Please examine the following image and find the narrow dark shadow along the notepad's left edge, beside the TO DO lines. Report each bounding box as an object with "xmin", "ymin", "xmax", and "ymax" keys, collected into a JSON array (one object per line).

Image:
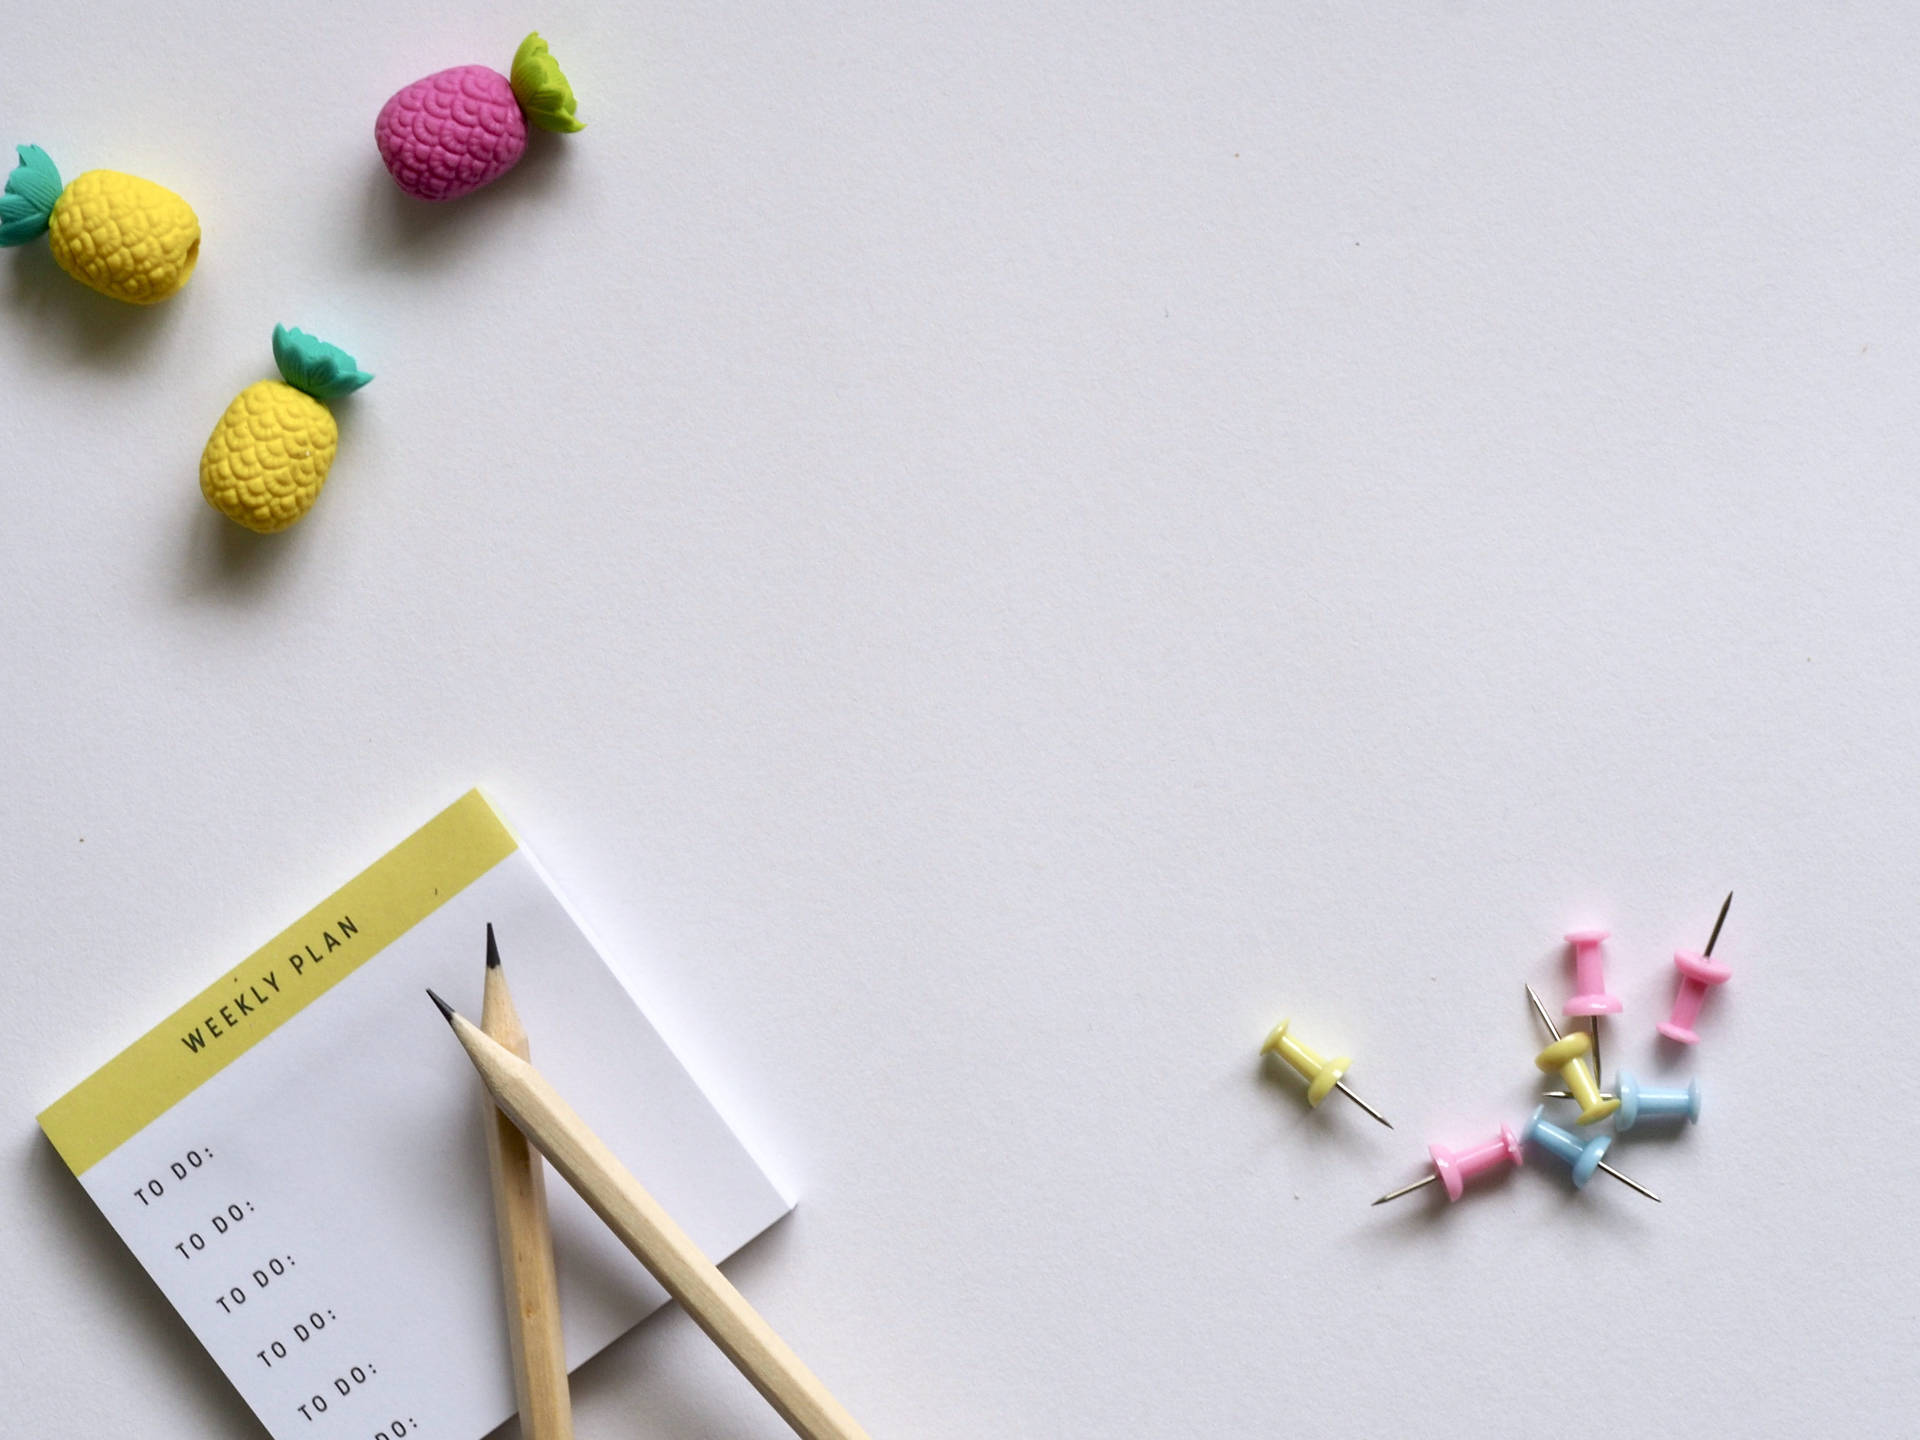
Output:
[{"xmin": 23, "ymin": 1129, "xmax": 261, "ymax": 1440}]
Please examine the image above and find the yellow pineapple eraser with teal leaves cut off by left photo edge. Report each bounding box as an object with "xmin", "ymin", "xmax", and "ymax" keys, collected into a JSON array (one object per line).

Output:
[{"xmin": 0, "ymin": 146, "xmax": 200, "ymax": 305}]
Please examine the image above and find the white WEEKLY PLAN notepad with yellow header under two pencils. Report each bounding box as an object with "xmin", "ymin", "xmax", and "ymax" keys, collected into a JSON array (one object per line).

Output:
[{"xmin": 40, "ymin": 791, "xmax": 789, "ymax": 1440}]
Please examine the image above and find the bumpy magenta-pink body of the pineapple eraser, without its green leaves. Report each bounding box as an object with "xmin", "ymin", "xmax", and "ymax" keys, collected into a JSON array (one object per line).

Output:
[{"xmin": 372, "ymin": 65, "xmax": 526, "ymax": 200}]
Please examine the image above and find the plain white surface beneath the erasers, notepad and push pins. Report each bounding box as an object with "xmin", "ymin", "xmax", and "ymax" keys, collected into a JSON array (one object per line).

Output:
[{"xmin": 0, "ymin": 0, "xmax": 1920, "ymax": 1440}]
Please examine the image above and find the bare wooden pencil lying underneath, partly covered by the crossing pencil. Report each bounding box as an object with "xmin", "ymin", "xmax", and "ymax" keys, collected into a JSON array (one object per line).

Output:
[{"xmin": 480, "ymin": 924, "xmax": 574, "ymax": 1440}]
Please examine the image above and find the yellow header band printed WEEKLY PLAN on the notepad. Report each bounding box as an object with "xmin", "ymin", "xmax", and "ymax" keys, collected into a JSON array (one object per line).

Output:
[{"xmin": 40, "ymin": 791, "xmax": 516, "ymax": 1175}]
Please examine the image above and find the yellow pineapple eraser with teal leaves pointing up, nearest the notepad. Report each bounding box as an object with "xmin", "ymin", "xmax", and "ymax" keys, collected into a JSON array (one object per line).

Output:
[{"xmin": 200, "ymin": 324, "xmax": 372, "ymax": 536}]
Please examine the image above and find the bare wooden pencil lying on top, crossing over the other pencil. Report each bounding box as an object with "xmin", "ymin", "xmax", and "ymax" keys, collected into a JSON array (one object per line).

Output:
[{"xmin": 428, "ymin": 991, "xmax": 868, "ymax": 1440}]
